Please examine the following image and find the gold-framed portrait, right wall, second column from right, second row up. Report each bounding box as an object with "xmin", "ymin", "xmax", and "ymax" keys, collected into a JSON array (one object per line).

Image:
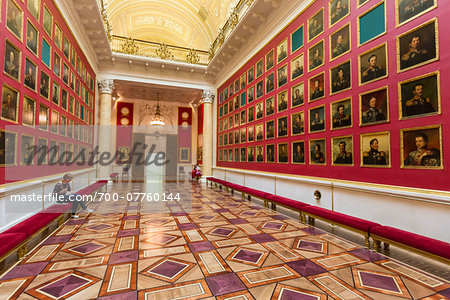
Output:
[{"xmin": 359, "ymin": 87, "xmax": 389, "ymax": 126}]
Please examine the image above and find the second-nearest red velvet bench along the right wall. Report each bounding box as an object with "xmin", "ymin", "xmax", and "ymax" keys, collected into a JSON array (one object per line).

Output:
[{"xmin": 301, "ymin": 205, "xmax": 380, "ymax": 248}]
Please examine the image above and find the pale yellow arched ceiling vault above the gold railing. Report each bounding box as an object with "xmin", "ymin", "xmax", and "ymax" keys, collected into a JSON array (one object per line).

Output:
[{"xmin": 107, "ymin": 0, "xmax": 238, "ymax": 51}]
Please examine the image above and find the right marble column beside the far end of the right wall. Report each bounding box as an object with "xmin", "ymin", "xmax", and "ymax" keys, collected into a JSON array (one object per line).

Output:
[{"xmin": 203, "ymin": 90, "xmax": 215, "ymax": 177}]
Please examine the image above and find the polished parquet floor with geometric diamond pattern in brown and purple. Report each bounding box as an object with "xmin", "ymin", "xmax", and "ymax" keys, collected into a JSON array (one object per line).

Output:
[{"xmin": 0, "ymin": 182, "xmax": 450, "ymax": 300}]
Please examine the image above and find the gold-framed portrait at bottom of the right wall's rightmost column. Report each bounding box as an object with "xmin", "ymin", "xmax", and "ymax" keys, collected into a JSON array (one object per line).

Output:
[{"xmin": 400, "ymin": 125, "xmax": 444, "ymax": 169}]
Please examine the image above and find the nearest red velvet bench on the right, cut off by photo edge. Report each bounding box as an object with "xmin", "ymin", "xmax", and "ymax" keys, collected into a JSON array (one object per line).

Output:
[{"xmin": 370, "ymin": 226, "xmax": 450, "ymax": 264}]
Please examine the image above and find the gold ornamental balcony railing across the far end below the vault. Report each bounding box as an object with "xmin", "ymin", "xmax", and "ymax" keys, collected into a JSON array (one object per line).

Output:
[{"xmin": 111, "ymin": 35, "xmax": 209, "ymax": 65}]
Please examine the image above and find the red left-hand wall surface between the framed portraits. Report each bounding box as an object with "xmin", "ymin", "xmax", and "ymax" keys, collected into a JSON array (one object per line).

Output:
[{"xmin": 0, "ymin": 0, "xmax": 96, "ymax": 184}]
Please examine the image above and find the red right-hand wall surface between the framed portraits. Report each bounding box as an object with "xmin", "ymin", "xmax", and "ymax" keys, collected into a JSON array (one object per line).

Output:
[{"xmin": 217, "ymin": 0, "xmax": 450, "ymax": 191}]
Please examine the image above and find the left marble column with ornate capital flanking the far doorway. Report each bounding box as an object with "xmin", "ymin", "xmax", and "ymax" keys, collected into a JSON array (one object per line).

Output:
[{"xmin": 97, "ymin": 79, "xmax": 115, "ymax": 179}]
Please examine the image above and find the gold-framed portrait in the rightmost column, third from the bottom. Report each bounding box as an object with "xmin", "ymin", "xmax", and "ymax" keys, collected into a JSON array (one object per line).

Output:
[{"xmin": 397, "ymin": 18, "xmax": 439, "ymax": 72}]
